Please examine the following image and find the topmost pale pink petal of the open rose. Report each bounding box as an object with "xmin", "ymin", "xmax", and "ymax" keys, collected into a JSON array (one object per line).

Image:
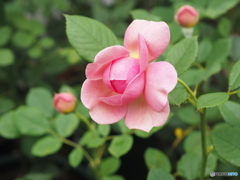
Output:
[{"xmin": 124, "ymin": 20, "xmax": 170, "ymax": 61}]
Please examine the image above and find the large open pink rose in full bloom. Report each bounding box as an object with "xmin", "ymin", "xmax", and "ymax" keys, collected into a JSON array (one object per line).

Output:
[{"xmin": 81, "ymin": 20, "xmax": 177, "ymax": 132}]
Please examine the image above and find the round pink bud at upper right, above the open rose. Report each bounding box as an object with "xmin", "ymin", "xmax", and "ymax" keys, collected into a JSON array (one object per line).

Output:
[{"xmin": 174, "ymin": 5, "xmax": 199, "ymax": 27}]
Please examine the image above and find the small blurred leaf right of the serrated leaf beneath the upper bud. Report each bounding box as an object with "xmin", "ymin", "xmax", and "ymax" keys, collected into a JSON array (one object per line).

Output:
[{"xmin": 197, "ymin": 39, "xmax": 212, "ymax": 63}]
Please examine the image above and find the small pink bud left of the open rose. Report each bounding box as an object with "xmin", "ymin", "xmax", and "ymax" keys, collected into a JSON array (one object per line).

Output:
[{"xmin": 53, "ymin": 92, "xmax": 76, "ymax": 113}]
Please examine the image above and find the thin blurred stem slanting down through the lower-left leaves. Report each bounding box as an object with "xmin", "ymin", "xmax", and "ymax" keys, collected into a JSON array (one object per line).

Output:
[{"xmin": 48, "ymin": 129, "xmax": 95, "ymax": 169}]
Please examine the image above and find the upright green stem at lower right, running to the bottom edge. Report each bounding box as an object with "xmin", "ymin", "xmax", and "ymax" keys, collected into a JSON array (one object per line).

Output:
[{"xmin": 200, "ymin": 109, "xmax": 207, "ymax": 180}]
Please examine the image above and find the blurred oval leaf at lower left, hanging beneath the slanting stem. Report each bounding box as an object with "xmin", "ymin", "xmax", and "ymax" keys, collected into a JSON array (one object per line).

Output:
[{"xmin": 32, "ymin": 136, "xmax": 62, "ymax": 157}]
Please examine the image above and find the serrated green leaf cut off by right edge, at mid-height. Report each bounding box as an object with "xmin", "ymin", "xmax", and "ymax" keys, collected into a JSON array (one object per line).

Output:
[{"xmin": 229, "ymin": 60, "xmax": 240, "ymax": 91}]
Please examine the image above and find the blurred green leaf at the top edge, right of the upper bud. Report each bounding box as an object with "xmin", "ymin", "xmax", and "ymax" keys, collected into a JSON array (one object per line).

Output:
[{"xmin": 205, "ymin": 0, "xmax": 239, "ymax": 19}]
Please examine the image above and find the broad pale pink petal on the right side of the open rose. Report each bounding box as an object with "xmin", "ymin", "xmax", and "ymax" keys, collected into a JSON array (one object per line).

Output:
[{"xmin": 144, "ymin": 61, "xmax": 177, "ymax": 111}]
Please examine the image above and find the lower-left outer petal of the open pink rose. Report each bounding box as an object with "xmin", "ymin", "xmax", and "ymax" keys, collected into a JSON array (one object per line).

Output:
[{"xmin": 89, "ymin": 101, "xmax": 127, "ymax": 124}]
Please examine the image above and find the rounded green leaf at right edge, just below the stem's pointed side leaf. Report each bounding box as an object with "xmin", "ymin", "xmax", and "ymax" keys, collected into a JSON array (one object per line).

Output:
[{"xmin": 219, "ymin": 101, "xmax": 240, "ymax": 127}]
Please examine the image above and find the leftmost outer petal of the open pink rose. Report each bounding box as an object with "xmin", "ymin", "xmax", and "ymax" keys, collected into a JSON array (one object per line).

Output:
[{"xmin": 81, "ymin": 79, "xmax": 113, "ymax": 109}]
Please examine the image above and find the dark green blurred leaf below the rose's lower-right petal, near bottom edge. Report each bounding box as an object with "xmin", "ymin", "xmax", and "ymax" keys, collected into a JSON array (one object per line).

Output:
[{"xmin": 144, "ymin": 148, "xmax": 171, "ymax": 173}]
